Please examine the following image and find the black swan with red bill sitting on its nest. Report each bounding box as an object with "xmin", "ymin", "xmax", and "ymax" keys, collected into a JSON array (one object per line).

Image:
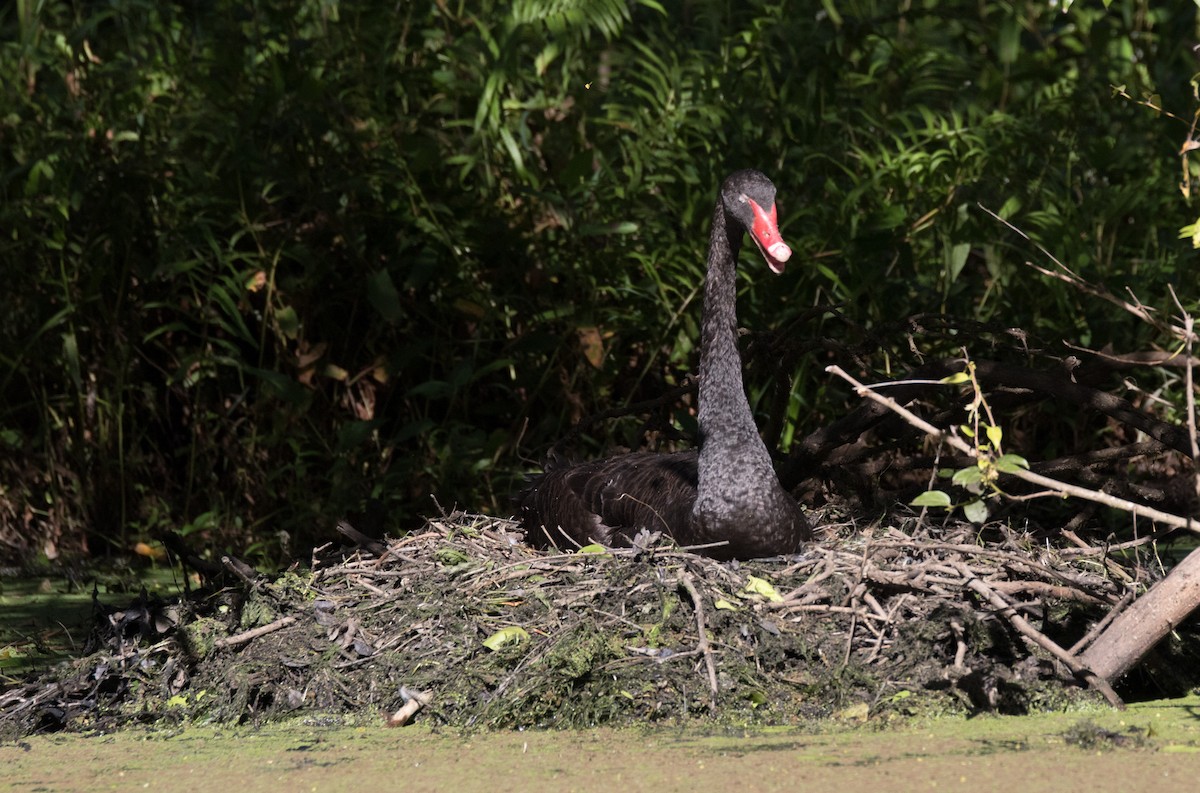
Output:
[{"xmin": 516, "ymin": 170, "xmax": 810, "ymax": 559}]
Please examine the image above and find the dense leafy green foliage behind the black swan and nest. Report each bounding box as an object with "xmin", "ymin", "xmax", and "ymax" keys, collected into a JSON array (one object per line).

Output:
[{"xmin": 0, "ymin": 0, "xmax": 1198, "ymax": 558}]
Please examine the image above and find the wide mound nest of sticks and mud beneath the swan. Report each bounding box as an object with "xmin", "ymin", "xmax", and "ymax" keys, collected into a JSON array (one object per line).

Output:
[{"xmin": 7, "ymin": 503, "xmax": 1190, "ymax": 735}]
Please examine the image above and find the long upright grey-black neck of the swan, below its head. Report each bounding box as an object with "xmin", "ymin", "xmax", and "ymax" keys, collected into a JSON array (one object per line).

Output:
[{"xmin": 696, "ymin": 200, "xmax": 778, "ymax": 515}]
